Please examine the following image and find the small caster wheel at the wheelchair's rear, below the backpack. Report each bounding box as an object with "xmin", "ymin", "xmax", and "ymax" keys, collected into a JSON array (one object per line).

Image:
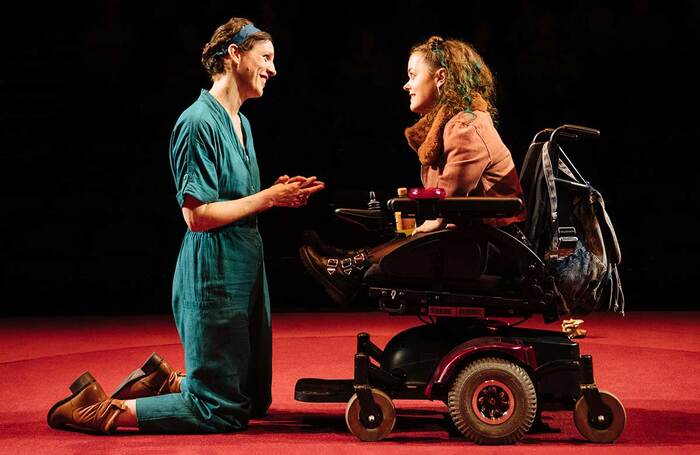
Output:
[{"xmin": 574, "ymin": 390, "xmax": 627, "ymax": 443}]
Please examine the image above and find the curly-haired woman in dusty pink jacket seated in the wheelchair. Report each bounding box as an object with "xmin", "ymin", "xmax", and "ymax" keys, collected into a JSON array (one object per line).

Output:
[{"xmin": 300, "ymin": 36, "xmax": 526, "ymax": 304}]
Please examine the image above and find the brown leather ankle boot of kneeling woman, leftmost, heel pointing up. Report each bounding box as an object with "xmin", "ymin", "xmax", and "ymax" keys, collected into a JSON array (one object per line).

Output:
[{"xmin": 46, "ymin": 372, "xmax": 127, "ymax": 433}]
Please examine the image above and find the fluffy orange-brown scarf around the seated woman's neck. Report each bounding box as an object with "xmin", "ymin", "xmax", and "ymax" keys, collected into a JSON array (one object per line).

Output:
[{"xmin": 405, "ymin": 93, "xmax": 488, "ymax": 168}]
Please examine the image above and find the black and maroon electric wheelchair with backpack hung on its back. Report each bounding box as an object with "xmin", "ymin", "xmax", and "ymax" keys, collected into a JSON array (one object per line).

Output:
[{"xmin": 295, "ymin": 125, "xmax": 626, "ymax": 444}]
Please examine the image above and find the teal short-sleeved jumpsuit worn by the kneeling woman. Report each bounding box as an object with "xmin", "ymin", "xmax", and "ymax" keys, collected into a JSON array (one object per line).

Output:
[{"xmin": 136, "ymin": 90, "xmax": 272, "ymax": 433}]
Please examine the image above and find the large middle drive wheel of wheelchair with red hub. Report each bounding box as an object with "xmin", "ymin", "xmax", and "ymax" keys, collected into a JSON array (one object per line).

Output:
[{"xmin": 447, "ymin": 358, "xmax": 537, "ymax": 444}]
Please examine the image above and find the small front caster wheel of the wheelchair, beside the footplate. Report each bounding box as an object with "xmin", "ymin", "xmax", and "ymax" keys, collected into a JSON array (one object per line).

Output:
[{"xmin": 345, "ymin": 389, "xmax": 396, "ymax": 441}]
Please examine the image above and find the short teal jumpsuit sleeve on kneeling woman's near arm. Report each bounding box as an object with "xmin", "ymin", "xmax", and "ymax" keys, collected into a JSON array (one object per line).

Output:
[{"xmin": 170, "ymin": 122, "xmax": 219, "ymax": 207}]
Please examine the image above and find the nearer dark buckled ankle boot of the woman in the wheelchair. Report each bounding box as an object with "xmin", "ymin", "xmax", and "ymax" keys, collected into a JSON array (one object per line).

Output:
[{"xmin": 299, "ymin": 245, "xmax": 370, "ymax": 305}]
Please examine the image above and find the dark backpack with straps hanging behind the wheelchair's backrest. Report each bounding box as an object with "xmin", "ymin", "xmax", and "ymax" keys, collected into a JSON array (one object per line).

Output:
[{"xmin": 520, "ymin": 125, "xmax": 625, "ymax": 316}]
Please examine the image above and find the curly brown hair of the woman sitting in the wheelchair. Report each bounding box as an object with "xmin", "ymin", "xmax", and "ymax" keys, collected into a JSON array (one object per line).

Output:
[{"xmin": 409, "ymin": 36, "xmax": 498, "ymax": 122}]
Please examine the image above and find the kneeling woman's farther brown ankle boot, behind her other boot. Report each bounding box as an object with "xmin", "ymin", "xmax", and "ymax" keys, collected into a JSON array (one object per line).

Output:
[{"xmin": 112, "ymin": 352, "xmax": 185, "ymax": 400}]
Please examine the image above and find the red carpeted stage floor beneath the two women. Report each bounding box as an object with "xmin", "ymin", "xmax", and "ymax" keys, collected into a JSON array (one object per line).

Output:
[{"xmin": 0, "ymin": 312, "xmax": 700, "ymax": 455}]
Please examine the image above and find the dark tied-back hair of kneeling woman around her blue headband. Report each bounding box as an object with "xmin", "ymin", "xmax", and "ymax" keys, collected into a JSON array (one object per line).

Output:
[{"xmin": 202, "ymin": 17, "xmax": 272, "ymax": 78}]
